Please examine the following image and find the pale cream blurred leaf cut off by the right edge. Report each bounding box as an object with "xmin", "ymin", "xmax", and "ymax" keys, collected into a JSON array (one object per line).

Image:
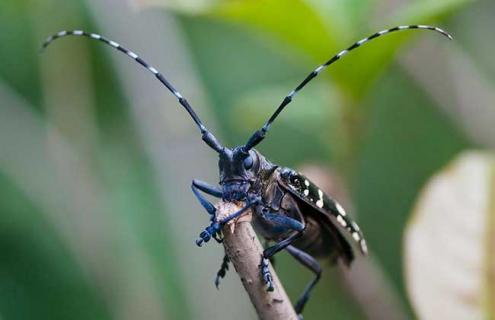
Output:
[{"xmin": 404, "ymin": 152, "xmax": 495, "ymax": 319}]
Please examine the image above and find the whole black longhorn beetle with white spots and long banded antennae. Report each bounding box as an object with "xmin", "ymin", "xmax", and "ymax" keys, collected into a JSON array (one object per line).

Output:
[{"xmin": 42, "ymin": 25, "xmax": 452, "ymax": 315}]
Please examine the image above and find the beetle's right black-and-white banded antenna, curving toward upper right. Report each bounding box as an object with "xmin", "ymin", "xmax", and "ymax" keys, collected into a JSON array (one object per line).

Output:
[{"xmin": 244, "ymin": 25, "xmax": 452, "ymax": 150}]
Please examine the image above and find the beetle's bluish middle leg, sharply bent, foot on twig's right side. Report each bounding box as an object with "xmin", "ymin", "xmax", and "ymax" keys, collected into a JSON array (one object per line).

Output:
[{"xmin": 260, "ymin": 213, "xmax": 305, "ymax": 291}]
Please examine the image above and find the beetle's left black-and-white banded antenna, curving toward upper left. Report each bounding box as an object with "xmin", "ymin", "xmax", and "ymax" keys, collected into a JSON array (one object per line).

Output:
[{"xmin": 41, "ymin": 30, "xmax": 223, "ymax": 153}]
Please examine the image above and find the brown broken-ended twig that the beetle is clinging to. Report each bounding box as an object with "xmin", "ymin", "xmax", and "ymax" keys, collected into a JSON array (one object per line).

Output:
[{"xmin": 217, "ymin": 202, "xmax": 297, "ymax": 320}]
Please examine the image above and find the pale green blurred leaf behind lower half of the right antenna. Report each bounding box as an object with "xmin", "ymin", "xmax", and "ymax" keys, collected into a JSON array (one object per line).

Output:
[{"xmin": 228, "ymin": 80, "xmax": 342, "ymax": 165}]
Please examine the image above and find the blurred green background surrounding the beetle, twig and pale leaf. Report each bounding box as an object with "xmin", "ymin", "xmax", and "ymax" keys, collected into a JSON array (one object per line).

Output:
[{"xmin": 0, "ymin": 0, "xmax": 495, "ymax": 319}]
